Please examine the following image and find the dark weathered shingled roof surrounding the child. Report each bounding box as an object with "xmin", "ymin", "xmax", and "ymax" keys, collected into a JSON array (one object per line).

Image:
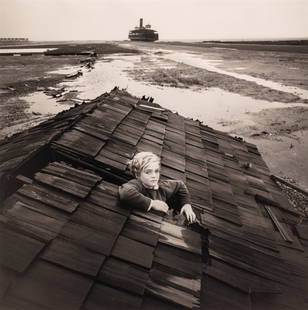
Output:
[{"xmin": 0, "ymin": 90, "xmax": 308, "ymax": 310}]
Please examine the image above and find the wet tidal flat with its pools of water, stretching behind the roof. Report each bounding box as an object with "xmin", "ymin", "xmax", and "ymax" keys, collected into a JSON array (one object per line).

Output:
[{"xmin": 0, "ymin": 42, "xmax": 308, "ymax": 189}]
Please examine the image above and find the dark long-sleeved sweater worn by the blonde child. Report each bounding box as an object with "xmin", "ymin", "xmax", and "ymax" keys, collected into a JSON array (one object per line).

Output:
[{"xmin": 119, "ymin": 179, "xmax": 191, "ymax": 211}]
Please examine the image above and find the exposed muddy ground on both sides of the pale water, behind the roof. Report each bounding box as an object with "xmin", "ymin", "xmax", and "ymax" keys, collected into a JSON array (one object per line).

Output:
[{"xmin": 0, "ymin": 42, "xmax": 308, "ymax": 190}]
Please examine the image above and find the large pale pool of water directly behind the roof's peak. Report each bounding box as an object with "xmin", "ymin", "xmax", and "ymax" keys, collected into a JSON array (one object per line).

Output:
[{"xmin": 54, "ymin": 55, "xmax": 305, "ymax": 131}]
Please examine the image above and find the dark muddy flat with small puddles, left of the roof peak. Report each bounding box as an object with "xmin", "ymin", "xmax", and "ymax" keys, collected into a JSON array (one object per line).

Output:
[{"xmin": 0, "ymin": 42, "xmax": 136, "ymax": 140}]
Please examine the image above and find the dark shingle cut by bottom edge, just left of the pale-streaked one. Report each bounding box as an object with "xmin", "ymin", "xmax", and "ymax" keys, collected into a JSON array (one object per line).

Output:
[{"xmin": 84, "ymin": 283, "xmax": 142, "ymax": 310}]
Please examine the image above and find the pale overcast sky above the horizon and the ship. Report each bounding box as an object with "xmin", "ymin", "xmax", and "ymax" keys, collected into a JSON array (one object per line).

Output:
[{"xmin": 0, "ymin": 0, "xmax": 308, "ymax": 40}]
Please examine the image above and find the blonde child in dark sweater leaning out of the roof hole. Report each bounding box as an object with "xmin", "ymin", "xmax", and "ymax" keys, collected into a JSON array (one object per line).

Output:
[{"xmin": 119, "ymin": 152, "xmax": 196, "ymax": 223}]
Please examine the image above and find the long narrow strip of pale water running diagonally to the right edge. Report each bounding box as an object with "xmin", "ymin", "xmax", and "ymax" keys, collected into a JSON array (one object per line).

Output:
[{"xmin": 162, "ymin": 52, "xmax": 308, "ymax": 99}]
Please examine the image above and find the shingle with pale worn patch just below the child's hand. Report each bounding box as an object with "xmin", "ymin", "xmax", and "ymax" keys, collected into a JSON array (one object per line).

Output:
[{"xmin": 159, "ymin": 222, "xmax": 202, "ymax": 255}]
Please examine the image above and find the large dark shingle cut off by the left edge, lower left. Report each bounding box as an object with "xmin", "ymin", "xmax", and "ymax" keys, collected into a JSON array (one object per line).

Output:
[{"xmin": 0, "ymin": 227, "xmax": 45, "ymax": 272}]
